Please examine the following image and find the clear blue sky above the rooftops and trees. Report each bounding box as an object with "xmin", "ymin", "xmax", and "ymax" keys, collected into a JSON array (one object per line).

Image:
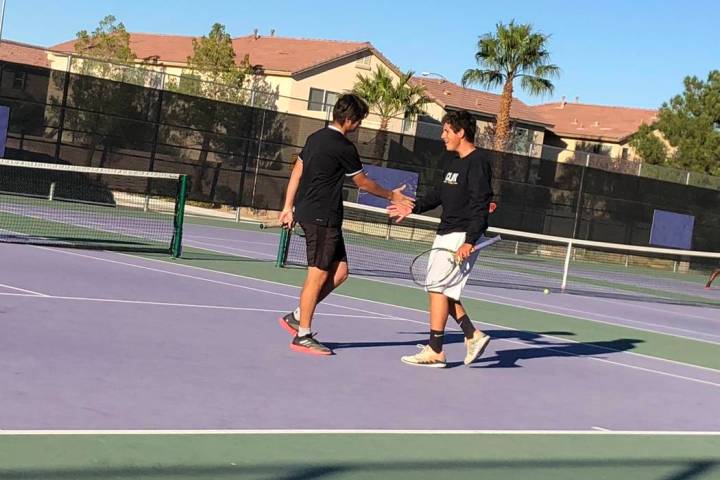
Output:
[{"xmin": 3, "ymin": 0, "xmax": 720, "ymax": 108}]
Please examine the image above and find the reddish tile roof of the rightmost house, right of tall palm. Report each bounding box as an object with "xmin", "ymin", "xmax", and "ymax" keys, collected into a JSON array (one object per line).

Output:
[{"xmin": 531, "ymin": 102, "xmax": 657, "ymax": 142}]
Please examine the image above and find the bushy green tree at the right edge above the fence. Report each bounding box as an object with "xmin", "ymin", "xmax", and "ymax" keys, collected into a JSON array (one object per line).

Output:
[{"xmin": 654, "ymin": 70, "xmax": 720, "ymax": 175}]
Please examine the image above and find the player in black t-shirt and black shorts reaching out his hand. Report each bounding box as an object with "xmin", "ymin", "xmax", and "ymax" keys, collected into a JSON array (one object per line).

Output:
[{"xmin": 280, "ymin": 94, "xmax": 413, "ymax": 355}]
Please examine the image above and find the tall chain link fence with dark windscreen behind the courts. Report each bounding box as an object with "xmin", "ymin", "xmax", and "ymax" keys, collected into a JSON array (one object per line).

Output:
[{"xmin": 0, "ymin": 57, "xmax": 720, "ymax": 250}]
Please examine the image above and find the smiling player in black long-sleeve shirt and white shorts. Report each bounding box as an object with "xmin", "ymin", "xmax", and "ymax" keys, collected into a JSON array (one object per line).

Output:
[{"xmin": 388, "ymin": 111, "xmax": 492, "ymax": 368}]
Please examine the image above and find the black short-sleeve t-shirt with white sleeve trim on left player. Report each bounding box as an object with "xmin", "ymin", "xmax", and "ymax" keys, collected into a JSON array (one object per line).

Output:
[{"xmin": 295, "ymin": 127, "xmax": 363, "ymax": 227}]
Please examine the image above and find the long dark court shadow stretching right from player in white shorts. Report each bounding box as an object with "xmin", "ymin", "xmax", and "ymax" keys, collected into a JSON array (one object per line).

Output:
[{"xmin": 472, "ymin": 338, "xmax": 644, "ymax": 368}]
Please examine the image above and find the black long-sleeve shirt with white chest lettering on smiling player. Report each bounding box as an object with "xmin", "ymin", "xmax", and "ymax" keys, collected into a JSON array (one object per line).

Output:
[{"xmin": 413, "ymin": 150, "xmax": 492, "ymax": 244}]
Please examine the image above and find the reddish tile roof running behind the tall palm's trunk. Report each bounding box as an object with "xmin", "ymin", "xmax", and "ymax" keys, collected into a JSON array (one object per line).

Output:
[{"xmin": 413, "ymin": 77, "xmax": 552, "ymax": 126}]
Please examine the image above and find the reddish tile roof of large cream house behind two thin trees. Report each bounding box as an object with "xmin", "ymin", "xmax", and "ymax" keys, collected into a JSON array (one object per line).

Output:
[{"xmin": 52, "ymin": 33, "xmax": 374, "ymax": 74}]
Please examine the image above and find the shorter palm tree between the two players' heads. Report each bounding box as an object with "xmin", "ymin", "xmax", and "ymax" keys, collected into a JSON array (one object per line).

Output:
[{"xmin": 352, "ymin": 66, "xmax": 431, "ymax": 158}]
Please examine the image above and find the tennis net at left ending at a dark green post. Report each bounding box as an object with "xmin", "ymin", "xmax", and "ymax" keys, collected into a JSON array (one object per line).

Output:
[{"xmin": 0, "ymin": 159, "xmax": 187, "ymax": 256}]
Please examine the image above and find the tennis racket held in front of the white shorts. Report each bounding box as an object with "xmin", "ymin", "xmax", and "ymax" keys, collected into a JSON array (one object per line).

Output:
[{"xmin": 410, "ymin": 235, "xmax": 500, "ymax": 288}]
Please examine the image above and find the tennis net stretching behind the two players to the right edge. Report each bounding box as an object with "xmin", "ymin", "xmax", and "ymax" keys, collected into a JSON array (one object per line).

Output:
[{"xmin": 277, "ymin": 202, "xmax": 720, "ymax": 305}]
